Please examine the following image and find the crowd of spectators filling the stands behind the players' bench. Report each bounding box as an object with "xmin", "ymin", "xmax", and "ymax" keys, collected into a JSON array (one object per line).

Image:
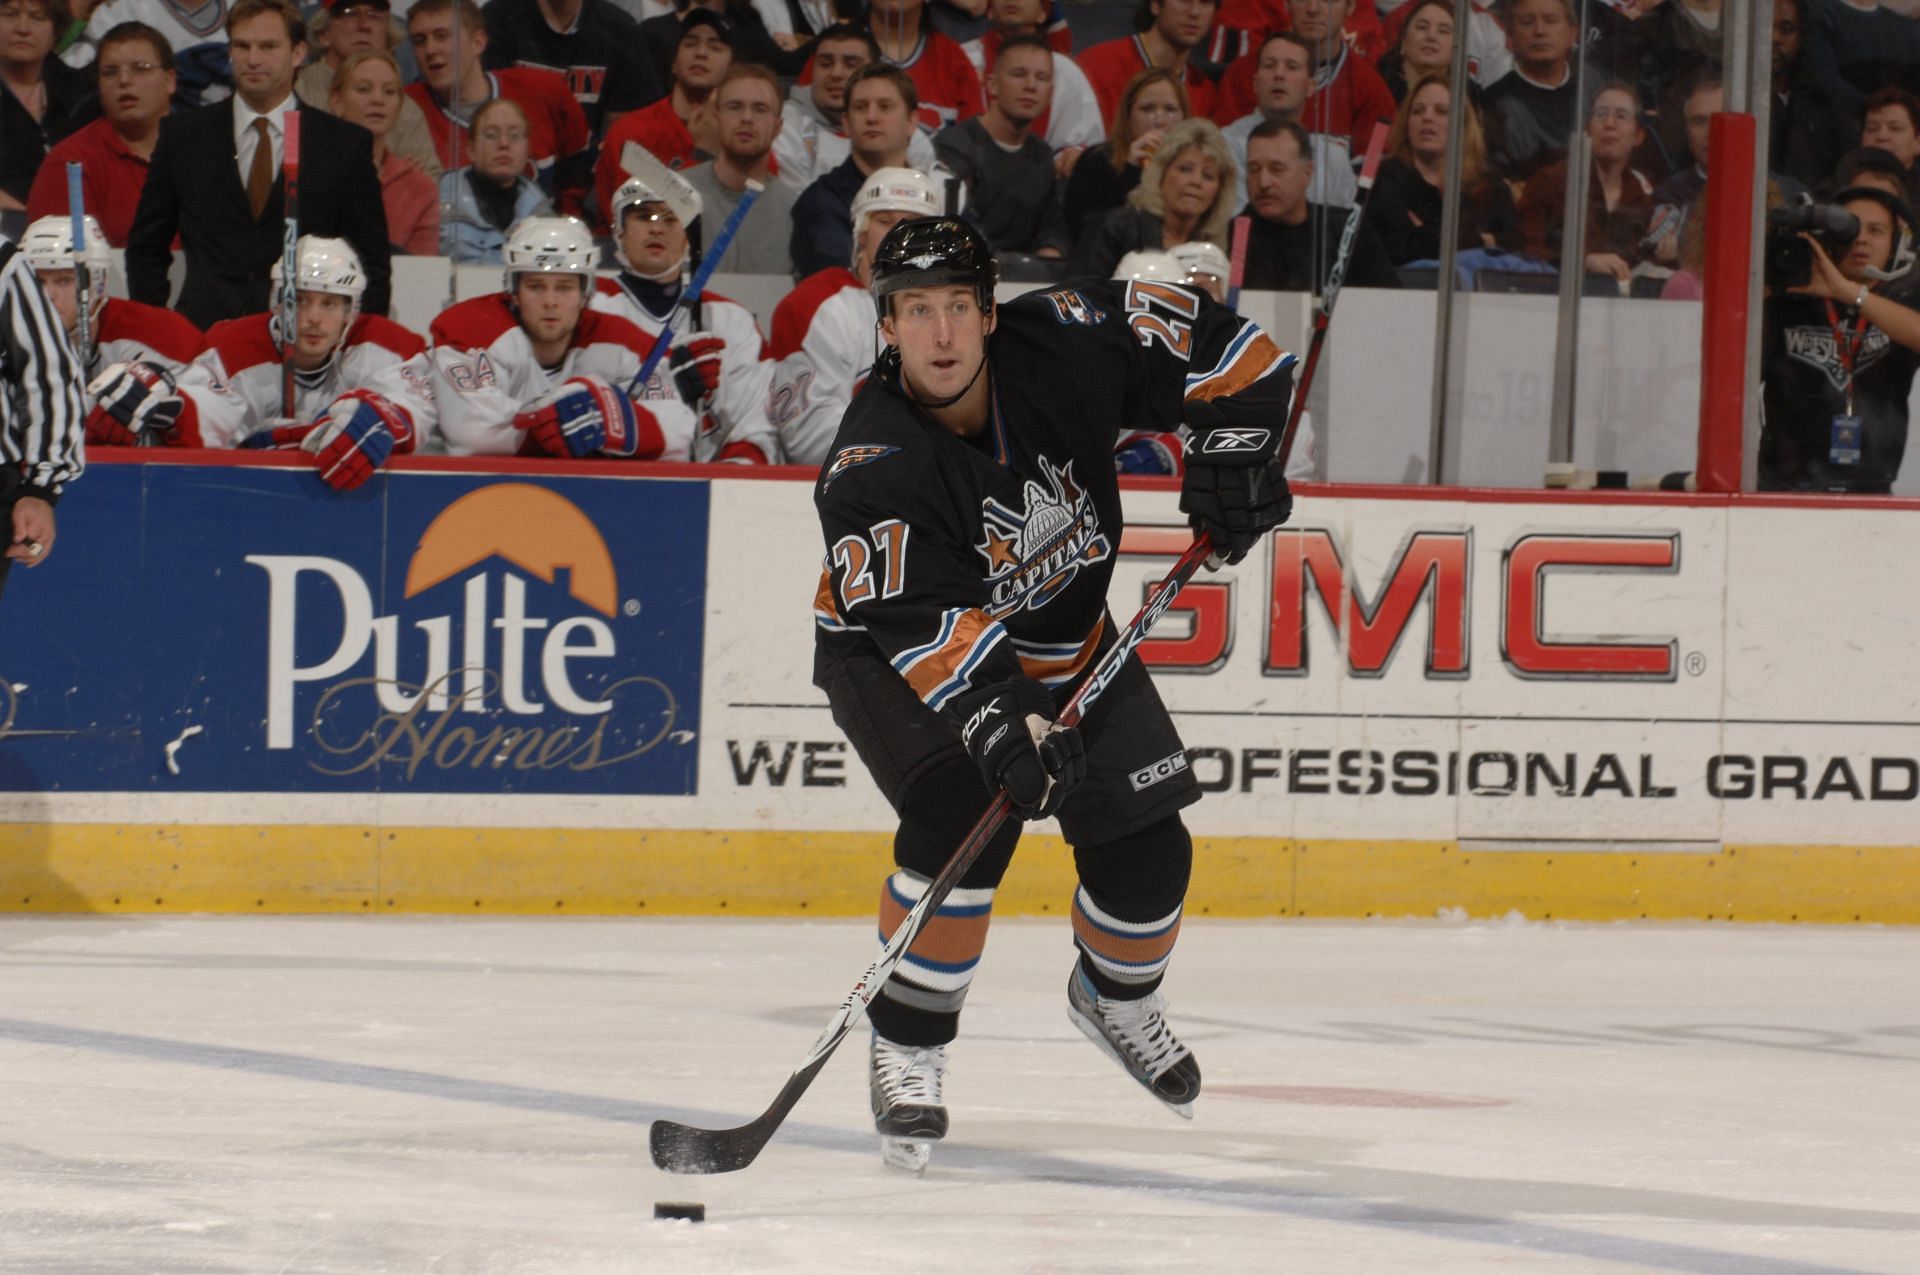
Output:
[{"xmin": 0, "ymin": 0, "xmax": 1920, "ymax": 487}]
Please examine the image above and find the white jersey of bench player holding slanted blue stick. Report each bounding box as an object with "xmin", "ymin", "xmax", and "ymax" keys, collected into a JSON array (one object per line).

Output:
[{"xmin": 593, "ymin": 278, "xmax": 780, "ymax": 463}]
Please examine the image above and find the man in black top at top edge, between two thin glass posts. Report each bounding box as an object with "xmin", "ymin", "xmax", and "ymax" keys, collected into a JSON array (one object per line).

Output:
[{"xmin": 1482, "ymin": 0, "xmax": 1597, "ymax": 182}]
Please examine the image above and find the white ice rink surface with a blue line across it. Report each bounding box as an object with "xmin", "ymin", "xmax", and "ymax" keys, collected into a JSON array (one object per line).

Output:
[{"xmin": 0, "ymin": 918, "xmax": 1920, "ymax": 1275}]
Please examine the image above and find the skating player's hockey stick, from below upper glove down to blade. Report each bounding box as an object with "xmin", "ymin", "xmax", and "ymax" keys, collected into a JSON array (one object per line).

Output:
[{"xmin": 647, "ymin": 534, "xmax": 1213, "ymax": 1173}]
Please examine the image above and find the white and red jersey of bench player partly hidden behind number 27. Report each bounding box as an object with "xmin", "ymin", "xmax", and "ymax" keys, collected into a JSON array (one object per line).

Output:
[{"xmin": 768, "ymin": 265, "xmax": 877, "ymax": 465}]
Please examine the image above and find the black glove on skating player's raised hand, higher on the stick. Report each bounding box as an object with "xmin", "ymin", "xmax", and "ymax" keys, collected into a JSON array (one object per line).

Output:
[{"xmin": 1181, "ymin": 403, "xmax": 1294, "ymax": 566}]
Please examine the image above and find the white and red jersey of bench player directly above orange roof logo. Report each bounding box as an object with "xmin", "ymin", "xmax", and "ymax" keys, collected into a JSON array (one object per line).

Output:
[{"xmin": 428, "ymin": 292, "xmax": 697, "ymax": 461}]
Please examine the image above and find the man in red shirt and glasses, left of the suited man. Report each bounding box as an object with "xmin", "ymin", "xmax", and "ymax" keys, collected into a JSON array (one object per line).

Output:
[{"xmin": 27, "ymin": 23, "xmax": 175, "ymax": 248}]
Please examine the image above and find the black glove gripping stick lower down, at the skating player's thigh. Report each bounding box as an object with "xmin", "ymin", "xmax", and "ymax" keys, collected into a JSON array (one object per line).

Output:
[{"xmin": 954, "ymin": 678, "xmax": 1087, "ymax": 820}]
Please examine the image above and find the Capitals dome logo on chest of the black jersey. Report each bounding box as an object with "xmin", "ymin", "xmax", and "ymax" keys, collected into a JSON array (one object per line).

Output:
[{"xmin": 973, "ymin": 457, "xmax": 1114, "ymax": 620}]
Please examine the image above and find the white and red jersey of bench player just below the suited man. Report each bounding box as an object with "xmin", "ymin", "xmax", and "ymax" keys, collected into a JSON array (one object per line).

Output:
[{"xmin": 177, "ymin": 315, "xmax": 434, "ymax": 449}]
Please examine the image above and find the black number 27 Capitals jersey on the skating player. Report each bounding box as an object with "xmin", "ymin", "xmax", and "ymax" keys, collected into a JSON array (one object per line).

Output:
[{"xmin": 814, "ymin": 280, "xmax": 1294, "ymax": 709}]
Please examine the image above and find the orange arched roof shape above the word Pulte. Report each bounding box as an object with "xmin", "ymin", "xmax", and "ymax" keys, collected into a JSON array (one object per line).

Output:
[{"xmin": 407, "ymin": 482, "xmax": 620, "ymax": 618}]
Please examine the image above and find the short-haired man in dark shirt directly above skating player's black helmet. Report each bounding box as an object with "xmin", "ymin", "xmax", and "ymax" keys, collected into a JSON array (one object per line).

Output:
[{"xmin": 933, "ymin": 35, "xmax": 1071, "ymax": 257}]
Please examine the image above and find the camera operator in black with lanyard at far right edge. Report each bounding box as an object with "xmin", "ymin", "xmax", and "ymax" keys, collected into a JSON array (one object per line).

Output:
[{"xmin": 1761, "ymin": 186, "xmax": 1920, "ymax": 493}]
